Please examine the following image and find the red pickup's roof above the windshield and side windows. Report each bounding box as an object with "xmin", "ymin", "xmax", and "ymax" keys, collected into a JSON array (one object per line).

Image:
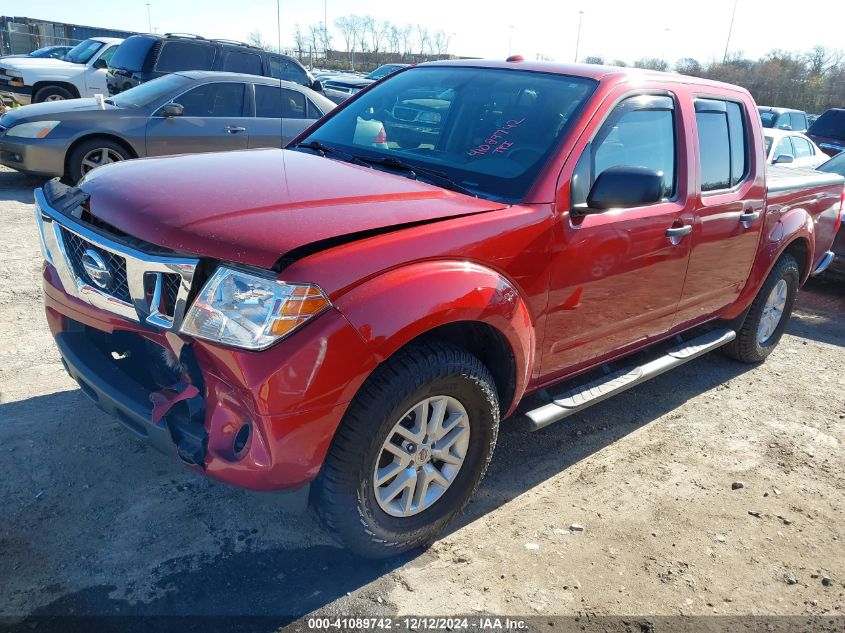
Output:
[{"xmin": 418, "ymin": 59, "xmax": 747, "ymax": 92}]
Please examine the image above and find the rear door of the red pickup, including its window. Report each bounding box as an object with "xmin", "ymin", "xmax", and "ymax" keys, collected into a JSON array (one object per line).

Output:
[{"xmin": 678, "ymin": 97, "xmax": 766, "ymax": 323}]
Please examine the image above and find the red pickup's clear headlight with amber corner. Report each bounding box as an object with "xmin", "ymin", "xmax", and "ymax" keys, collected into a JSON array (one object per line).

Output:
[{"xmin": 181, "ymin": 267, "xmax": 331, "ymax": 350}]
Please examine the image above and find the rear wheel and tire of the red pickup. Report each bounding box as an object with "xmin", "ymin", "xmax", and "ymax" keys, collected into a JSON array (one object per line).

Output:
[{"xmin": 724, "ymin": 254, "xmax": 801, "ymax": 363}]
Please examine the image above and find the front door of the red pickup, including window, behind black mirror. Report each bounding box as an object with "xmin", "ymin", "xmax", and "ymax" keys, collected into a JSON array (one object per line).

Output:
[{"xmin": 542, "ymin": 94, "xmax": 694, "ymax": 380}]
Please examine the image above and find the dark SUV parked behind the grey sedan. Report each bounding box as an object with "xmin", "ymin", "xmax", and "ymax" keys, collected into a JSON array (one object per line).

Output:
[{"xmin": 108, "ymin": 33, "xmax": 322, "ymax": 95}]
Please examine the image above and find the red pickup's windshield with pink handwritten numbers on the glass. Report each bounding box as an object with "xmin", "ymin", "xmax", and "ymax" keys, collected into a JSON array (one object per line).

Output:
[{"xmin": 296, "ymin": 66, "xmax": 596, "ymax": 202}]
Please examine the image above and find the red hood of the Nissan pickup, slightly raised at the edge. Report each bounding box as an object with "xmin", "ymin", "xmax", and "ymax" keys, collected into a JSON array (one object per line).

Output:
[{"xmin": 80, "ymin": 149, "xmax": 504, "ymax": 268}]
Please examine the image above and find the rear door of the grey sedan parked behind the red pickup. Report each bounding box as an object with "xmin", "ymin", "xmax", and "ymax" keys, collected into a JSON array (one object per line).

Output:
[{"xmin": 249, "ymin": 84, "xmax": 317, "ymax": 147}]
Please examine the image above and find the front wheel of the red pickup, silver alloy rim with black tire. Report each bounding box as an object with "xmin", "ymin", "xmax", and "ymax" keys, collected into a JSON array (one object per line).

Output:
[{"xmin": 315, "ymin": 341, "xmax": 499, "ymax": 558}]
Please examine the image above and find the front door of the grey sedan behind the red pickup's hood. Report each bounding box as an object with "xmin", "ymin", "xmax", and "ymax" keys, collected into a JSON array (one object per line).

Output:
[{"xmin": 147, "ymin": 82, "xmax": 253, "ymax": 156}]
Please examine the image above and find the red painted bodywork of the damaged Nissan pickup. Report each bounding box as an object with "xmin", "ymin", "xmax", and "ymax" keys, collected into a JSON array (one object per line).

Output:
[{"xmin": 44, "ymin": 61, "xmax": 841, "ymax": 490}]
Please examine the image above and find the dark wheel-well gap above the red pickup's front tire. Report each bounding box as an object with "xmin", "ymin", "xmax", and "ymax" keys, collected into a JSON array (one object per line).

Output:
[{"xmin": 411, "ymin": 321, "xmax": 516, "ymax": 415}]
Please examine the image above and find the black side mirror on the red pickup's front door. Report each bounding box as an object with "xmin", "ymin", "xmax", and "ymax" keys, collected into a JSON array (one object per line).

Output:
[{"xmin": 577, "ymin": 165, "xmax": 663, "ymax": 213}]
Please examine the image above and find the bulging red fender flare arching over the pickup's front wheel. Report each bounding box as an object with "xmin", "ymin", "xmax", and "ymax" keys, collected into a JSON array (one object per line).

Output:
[{"xmin": 335, "ymin": 261, "xmax": 535, "ymax": 414}]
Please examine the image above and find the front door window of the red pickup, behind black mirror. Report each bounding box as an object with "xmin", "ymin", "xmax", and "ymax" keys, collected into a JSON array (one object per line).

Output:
[{"xmin": 572, "ymin": 95, "xmax": 677, "ymax": 205}]
